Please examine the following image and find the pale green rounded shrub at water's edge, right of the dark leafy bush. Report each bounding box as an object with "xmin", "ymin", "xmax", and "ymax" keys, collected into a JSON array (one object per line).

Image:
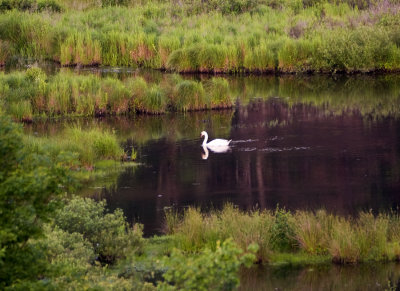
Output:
[{"xmin": 55, "ymin": 197, "xmax": 143, "ymax": 264}]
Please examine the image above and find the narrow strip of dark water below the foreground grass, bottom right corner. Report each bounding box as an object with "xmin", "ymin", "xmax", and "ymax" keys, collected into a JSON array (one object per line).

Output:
[{"xmin": 239, "ymin": 263, "xmax": 400, "ymax": 291}]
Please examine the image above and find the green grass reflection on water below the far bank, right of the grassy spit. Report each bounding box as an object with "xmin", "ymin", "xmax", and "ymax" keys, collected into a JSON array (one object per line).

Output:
[{"xmin": 232, "ymin": 75, "xmax": 400, "ymax": 118}]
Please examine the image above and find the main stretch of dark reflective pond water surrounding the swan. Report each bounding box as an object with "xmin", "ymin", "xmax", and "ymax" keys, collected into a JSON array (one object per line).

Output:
[{"xmin": 26, "ymin": 72, "xmax": 400, "ymax": 235}]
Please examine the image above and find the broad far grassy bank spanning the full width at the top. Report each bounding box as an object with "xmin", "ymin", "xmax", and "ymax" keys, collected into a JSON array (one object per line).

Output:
[{"xmin": 0, "ymin": 0, "xmax": 400, "ymax": 73}]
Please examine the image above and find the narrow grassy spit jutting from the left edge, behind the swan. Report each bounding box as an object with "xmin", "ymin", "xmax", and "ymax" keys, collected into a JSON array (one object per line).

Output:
[{"xmin": 0, "ymin": 67, "xmax": 233, "ymax": 121}]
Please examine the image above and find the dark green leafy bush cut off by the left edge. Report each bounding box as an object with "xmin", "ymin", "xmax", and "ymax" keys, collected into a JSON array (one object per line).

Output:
[{"xmin": 0, "ymin": 116, "xmax": 71, "ymax": 289}]
